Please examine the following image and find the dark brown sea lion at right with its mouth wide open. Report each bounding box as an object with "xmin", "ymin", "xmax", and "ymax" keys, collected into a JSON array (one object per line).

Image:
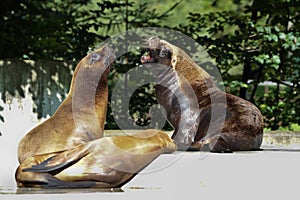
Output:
[{"xmin": 141, "ymin": 36, "xmax": 263, "ymax": 152}]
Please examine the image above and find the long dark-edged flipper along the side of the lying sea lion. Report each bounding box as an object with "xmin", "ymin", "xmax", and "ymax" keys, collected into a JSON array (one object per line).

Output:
[{"xmin": 23, "ymin": 145, "xmax": 88, "ymax": 173}]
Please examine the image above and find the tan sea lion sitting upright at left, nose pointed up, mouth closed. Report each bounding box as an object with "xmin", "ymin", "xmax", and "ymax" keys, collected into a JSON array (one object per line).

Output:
[{"xmin": 18, "ymin": 46, "xmax": 115, "ymax": 163}]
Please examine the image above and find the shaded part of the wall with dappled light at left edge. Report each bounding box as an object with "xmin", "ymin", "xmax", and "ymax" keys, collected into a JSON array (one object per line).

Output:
[{"xmin": 0, "ymin": 60, "xmax": 74, "ymax": 121}]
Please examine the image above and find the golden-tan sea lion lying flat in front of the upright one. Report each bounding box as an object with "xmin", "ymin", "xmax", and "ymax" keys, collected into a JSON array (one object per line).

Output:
[{"xmin": 16, "ymin": 129, "xmax": 176, "ymax": 188}]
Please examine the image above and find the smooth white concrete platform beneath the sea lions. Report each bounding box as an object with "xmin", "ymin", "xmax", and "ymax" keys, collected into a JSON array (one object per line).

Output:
[{"xmin": 0, "ymin": 149, "xmax": 300, "ymax": 200}]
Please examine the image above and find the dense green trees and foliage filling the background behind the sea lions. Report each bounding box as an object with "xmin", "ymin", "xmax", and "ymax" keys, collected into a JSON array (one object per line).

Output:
[{"xmin": 0, "ymin": 0, "xmax": 300, "ymax": 130}]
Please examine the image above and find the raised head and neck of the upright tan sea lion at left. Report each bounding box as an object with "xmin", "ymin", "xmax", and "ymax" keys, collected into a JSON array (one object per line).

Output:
[{"xmin": 69, "ymin": 47, "xmax": 115, "ymax": 140}]
